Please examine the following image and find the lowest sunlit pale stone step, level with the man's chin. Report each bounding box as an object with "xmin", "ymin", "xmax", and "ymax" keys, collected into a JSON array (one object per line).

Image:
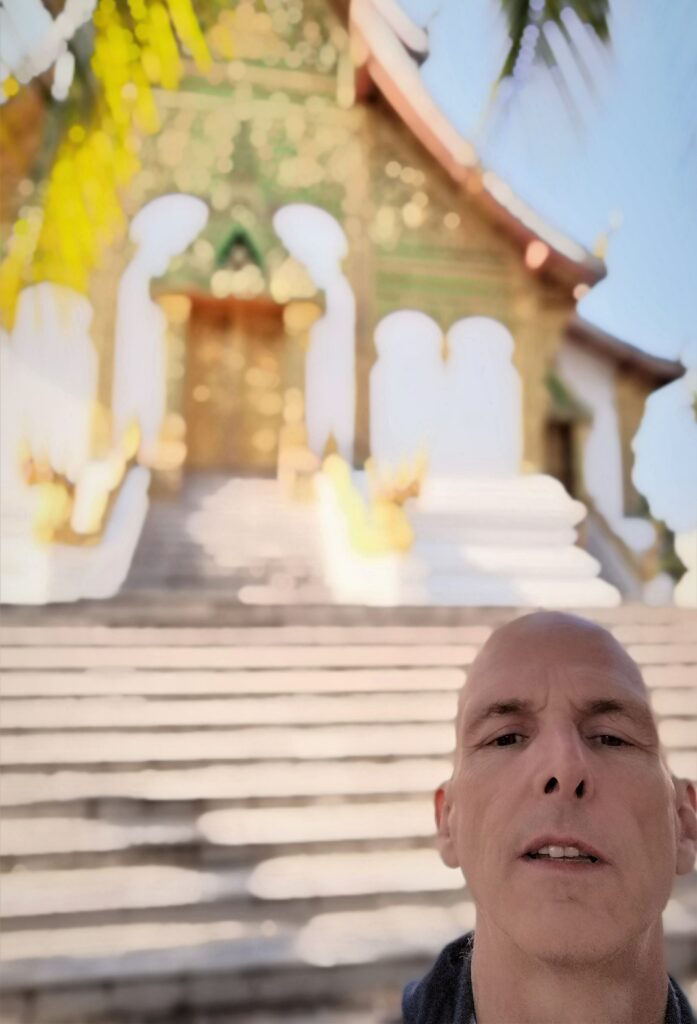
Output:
[{"xmin": 1, "ymin": 900, "xmax": 474, "ymax": 995}]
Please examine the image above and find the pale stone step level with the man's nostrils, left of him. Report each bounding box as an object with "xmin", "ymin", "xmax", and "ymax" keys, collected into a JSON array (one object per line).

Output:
[{"xmin": 0, "ymin": 755, "xmax": 450, "ymax": 808}]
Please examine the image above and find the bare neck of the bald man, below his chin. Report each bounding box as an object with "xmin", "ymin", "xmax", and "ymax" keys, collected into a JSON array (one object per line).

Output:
[{"xmin": 472, "ymin": 922, "xmax": 668, "ymax": 1024}]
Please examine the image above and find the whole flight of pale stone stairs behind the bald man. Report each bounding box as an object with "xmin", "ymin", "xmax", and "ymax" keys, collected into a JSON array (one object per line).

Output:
[{"xmin": 0, "ymin": 599, "xmax": 697, "ymax": 1024}]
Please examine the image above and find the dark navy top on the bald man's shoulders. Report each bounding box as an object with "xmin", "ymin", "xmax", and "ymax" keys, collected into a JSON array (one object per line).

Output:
[{"xmin": 402, "ymin": 932, "xmax": 695, "ymax": 1024}]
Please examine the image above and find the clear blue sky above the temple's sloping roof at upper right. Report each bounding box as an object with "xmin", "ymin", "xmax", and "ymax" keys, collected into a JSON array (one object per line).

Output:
[{"xmin": 399, "ymin": 0, "xmax": 697, "ymax": 362}]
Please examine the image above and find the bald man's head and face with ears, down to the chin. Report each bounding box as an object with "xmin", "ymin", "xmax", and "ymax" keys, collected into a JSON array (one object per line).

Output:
[{"xmin": 433, "ymin": 613, "xmax": 689, "ymax": 964}]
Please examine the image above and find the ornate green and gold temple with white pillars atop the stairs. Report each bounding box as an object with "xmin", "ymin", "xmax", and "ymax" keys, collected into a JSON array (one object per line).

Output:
[{"xmin": 2, "ymin": 0, "xmax": 689, "ymax": 604}]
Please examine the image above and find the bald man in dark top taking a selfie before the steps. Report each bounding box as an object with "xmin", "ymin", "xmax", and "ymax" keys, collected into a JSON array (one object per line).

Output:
[{"xmin": 403, "ymin": 612, "xmax": 697, "ymax": 1024}]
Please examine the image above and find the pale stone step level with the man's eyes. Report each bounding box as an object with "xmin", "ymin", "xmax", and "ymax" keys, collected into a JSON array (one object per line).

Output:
[{"xmin": 2, "ymin": 718, "xmax": 697, "ymax": 778}]
